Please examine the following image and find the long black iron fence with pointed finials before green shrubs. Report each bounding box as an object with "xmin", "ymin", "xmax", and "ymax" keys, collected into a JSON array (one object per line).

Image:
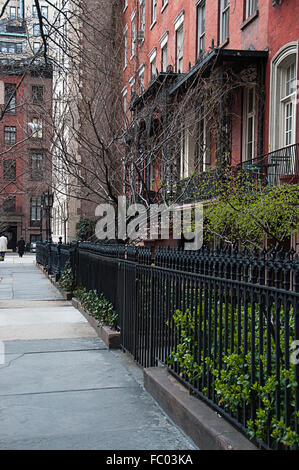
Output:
[{"xmin": 37, "ymin": 243, "xmax": 299, "ymax": 448}]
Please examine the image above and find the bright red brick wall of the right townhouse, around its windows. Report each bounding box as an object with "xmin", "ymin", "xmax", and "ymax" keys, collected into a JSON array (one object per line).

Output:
[{"xmin": 123, "ymin": 0, "xmax": 299, "ymax": 162}]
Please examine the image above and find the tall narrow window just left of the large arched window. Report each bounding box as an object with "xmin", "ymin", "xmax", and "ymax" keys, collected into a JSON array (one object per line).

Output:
[{"xmin": 242, "ymin": 87, "xmax": 255, "ymax": 161}]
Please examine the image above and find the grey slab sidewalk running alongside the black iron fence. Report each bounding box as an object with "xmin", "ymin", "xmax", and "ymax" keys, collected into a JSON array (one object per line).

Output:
[{"xmin": 0, "ymin": 255, "xmax": 197, "ymax": 450}]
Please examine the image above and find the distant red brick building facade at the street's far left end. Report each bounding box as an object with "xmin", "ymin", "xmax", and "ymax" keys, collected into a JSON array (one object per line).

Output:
[{"xmin": 0, "ymin": 64, "xmax": 52, "ymax": 250}]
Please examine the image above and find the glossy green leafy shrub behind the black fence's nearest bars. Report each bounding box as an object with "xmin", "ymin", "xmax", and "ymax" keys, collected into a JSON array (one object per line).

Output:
[{"xmin": 168, "ymin": 299, "xmax": 299, "ymax": 449}]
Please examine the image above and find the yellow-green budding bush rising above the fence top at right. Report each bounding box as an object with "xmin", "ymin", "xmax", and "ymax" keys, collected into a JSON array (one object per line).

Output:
[{"xmin": 188, "ymin": 166, "xmax": 299, "ymax": 252}]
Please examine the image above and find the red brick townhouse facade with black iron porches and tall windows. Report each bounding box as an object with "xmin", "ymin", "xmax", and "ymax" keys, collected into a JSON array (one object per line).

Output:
[{"xmin": 122, "ymin": 0, "xmax": 299, "ymax": 248}]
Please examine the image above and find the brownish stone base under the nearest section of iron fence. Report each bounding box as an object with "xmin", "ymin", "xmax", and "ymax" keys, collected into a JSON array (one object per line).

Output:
[{"xmin": 144, "ymin": 367, "xmax": 258, "ymax": 450}]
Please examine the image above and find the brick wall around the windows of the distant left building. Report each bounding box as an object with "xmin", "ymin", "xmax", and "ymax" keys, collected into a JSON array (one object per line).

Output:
[{"xmin": 0, "ymin": 73, "xmax": 52, "ymax": 246}]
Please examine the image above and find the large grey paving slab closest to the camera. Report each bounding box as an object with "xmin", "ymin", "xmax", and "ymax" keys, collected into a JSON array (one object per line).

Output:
[{"xmin": 0, "ymin": 387, "xmax": 194, "ymax": 450}]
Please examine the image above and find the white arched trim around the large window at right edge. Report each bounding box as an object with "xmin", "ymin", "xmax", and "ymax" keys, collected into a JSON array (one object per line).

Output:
[{"xmin": 269, "ymin": 42, "xmax": 298, "ymax": 152}]
